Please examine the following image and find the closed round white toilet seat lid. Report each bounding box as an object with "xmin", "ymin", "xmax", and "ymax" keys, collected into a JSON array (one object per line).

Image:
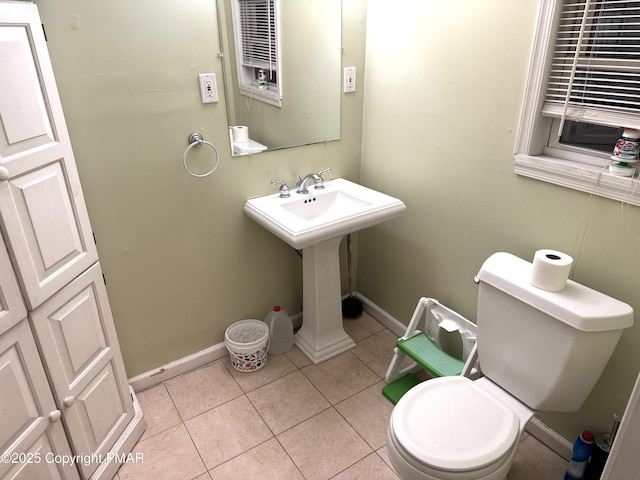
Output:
[{"xmin": 391, "ymin": 377, "xmax": 520, "ymax": 471}]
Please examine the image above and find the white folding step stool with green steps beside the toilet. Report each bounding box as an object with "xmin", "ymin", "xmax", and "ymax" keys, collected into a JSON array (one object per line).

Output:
[{"xmin": 382, "ymin": 297, "xmax": 479, "ymax": 405}]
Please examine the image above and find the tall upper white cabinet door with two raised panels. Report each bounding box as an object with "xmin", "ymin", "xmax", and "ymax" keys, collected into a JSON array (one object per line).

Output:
[{"xmin": 0, "ymin": 2, "xmax": 98, "ymax": 310}]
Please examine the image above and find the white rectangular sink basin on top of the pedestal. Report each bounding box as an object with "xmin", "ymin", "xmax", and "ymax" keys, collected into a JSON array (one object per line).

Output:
[{"xmin": 244, "ymin": 178, "xmax": 407, "ymax": 250}]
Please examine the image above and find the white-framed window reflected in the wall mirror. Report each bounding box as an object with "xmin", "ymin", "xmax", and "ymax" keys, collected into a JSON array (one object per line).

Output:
[{"xmin": 233, "ymin": 0, "xmax": 282, "ymax": 107}]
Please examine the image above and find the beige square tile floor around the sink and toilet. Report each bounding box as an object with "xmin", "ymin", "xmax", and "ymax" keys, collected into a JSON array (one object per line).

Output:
[{"xmin": 114, "ymin": 313, "xmax": 566, "ymax": 480}]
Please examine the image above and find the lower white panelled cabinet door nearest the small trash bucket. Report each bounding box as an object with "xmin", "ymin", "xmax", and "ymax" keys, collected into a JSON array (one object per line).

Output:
[{"xmin": 29, "ymin": 263, "xmax": 135, "ymax": 478}]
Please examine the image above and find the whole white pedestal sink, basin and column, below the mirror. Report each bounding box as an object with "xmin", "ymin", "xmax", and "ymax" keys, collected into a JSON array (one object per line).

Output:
[{"xmin": 244, "ymin": 178, "xmax": 406, "ymax": 363}]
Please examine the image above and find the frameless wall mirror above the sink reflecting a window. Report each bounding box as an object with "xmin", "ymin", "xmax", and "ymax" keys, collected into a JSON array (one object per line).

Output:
[{"xmin": 217, "ymin": 0, "xmax": 342, "ymax": 156}]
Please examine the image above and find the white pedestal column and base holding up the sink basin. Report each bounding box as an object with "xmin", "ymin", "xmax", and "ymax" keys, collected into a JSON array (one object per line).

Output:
[{"xmin": 294, "ymin": 237, "xmax": 356, "ymax": 363}]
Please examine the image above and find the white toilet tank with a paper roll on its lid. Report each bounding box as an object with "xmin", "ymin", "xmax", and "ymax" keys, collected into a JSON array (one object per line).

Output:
[{"xmin": 477, "ymin": 252, "xmax": 633, "ymax": 412}]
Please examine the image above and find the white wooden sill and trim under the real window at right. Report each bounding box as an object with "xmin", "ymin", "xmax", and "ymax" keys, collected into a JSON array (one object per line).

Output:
[{"xmin": 514, "ymin": 154, "xmax": 640, "ymax": 206}]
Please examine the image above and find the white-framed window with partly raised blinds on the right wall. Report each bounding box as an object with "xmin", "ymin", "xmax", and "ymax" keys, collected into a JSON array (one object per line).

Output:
[{"xmin": 515, "ymin": 0, "xmax": 640, "ymax": 205}]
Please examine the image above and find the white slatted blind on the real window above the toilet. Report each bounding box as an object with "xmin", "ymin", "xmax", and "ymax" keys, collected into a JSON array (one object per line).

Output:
[{"xmin": 542, "ymin": 0, "xmax": 640, "ymax": 128}]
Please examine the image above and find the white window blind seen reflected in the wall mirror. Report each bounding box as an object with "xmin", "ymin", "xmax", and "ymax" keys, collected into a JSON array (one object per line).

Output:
[{"xmin": 238, "ymin": 0, "xmax": 278, "ymax": 71}]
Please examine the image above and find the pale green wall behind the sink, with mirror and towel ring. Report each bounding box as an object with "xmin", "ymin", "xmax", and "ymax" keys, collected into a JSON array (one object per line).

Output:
[{"xmin": 36, "ymin": 0, "xmax": 365, "ymax": 376}]
